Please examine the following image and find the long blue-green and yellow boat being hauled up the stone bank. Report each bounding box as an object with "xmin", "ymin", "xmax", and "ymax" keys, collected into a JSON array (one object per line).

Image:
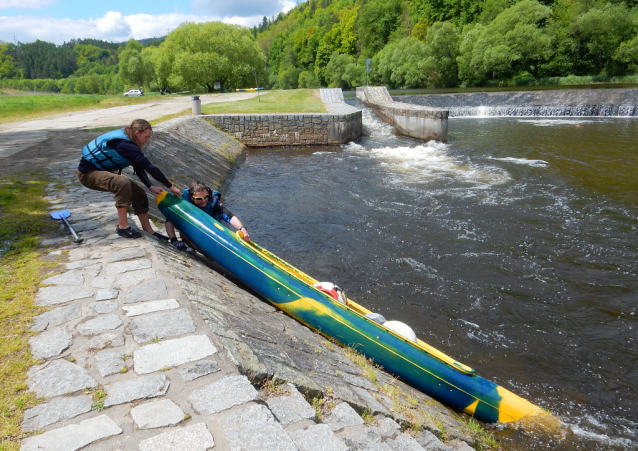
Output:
[{"xmin": 157, "ymin": 192, "xmax": 553, "ymax": 424}]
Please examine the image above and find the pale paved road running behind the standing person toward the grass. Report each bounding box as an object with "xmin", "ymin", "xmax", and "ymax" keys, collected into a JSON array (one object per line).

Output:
[{"xmin": 0, "ymin": 92, "xmax": 257, "ymax": 162}]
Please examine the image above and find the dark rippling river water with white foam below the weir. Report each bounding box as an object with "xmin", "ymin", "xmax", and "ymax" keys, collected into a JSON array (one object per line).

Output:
[{"xmin": 224, "ymin": 105, "xmax": 638, "ymax": 450}]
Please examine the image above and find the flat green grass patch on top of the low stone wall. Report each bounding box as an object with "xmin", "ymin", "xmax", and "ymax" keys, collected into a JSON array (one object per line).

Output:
[{"xmin": 202, "ymin": 89, "xmax": 326, "ymax": 114}]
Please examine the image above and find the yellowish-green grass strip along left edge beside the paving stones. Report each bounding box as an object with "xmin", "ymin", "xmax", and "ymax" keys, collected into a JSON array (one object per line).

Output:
[{"xmin": 0, "ymin": 177, "xmax": 57, "ymax": 451}]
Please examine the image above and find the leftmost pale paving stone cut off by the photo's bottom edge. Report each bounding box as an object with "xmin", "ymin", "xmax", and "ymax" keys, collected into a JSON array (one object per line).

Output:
[{"xmin": 20, "ymin": 415, "xmax": 122, "ymax": 451}]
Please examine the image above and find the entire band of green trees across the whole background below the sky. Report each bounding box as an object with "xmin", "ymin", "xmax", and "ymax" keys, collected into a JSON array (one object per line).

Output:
[{"xmin": 0, "ymin": 0, "xmax": 638, "ymax": 93}]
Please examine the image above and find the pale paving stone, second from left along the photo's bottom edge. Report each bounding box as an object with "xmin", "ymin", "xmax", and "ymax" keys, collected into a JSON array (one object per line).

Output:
[{"xmin": 139, "ymin": 423, "xmax": 215, "ymax": 451}]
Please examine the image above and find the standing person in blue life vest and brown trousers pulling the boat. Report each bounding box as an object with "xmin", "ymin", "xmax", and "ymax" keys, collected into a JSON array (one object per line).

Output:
[{"xmin": 77, "ymin": 119, "xmax": 181, "ymax": 240}]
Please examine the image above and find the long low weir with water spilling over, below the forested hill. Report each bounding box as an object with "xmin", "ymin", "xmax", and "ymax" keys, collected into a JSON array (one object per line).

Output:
[{"xmin": 393, "ymin": 89, "xmax": 638, "ymax": 117}]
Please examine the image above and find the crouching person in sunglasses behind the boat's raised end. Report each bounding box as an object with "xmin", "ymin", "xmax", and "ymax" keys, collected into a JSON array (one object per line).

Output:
[{"xmin": 166, "ymin": 181, "xmax": 250, "ymax": 250}]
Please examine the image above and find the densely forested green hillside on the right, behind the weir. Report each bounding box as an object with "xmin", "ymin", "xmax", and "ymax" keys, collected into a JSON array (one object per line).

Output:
[{"xmin": 253, "ymin": 0, "xmax": 638, "ymax": 88}]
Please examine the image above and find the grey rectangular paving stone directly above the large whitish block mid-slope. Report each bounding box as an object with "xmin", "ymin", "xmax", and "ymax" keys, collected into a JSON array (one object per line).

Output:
[{"xmin": 129, "ymin": 309, "xmax": 195, "ymax": 343}]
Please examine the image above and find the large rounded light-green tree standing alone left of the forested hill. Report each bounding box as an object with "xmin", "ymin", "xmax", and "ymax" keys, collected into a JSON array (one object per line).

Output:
[{"xmin": 159, "ymin": 22, "xmax": 268, "ymax": 92}]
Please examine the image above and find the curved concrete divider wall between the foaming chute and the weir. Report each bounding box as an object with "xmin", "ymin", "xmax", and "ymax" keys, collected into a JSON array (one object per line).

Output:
[{"xmin": 357, "ymin": 86, "xmax": 449, "ymax": 141}]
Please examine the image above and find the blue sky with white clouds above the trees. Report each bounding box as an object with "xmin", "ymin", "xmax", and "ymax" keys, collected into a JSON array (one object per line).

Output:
[{"xmin": 0, "ymin": 0, "xmax": 296, "ymax": 44}]
